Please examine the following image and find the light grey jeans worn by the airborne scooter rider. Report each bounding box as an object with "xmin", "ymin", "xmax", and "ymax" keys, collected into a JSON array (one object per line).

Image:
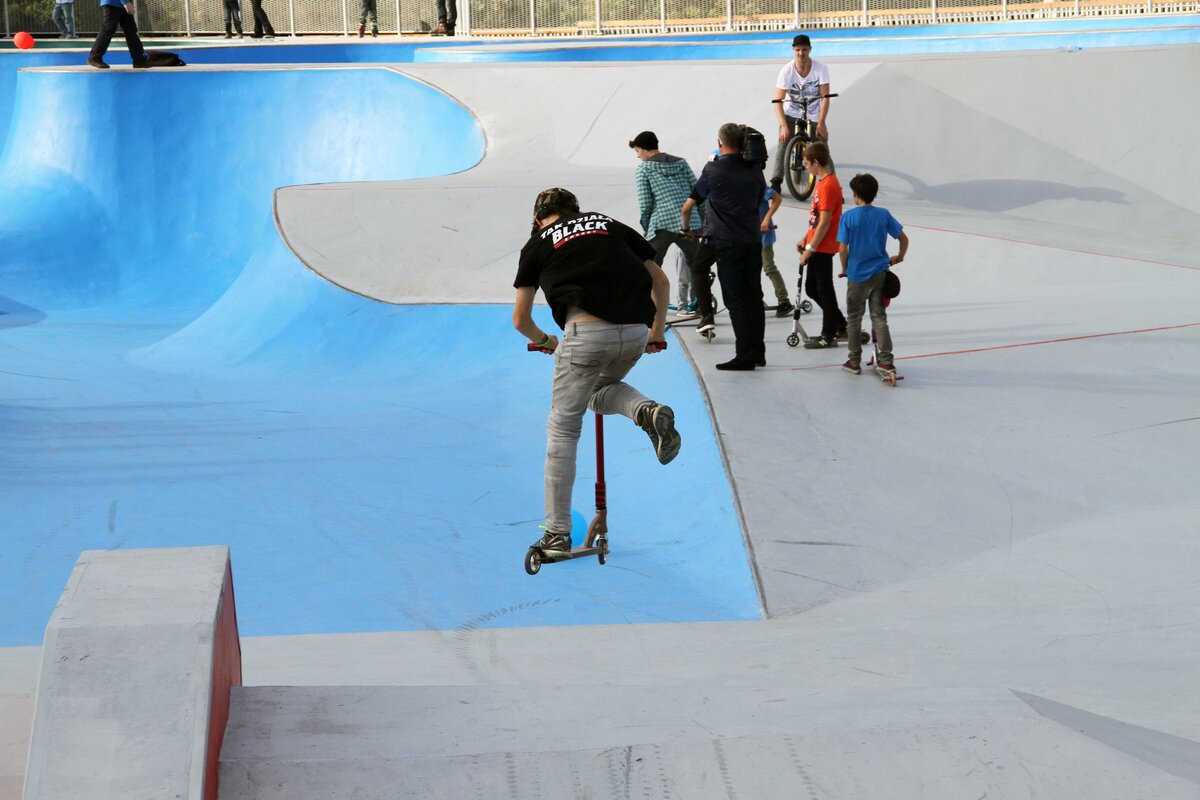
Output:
[{"xmin": 545, "ymin": 323, "xmax": 650, "ymax": 534}]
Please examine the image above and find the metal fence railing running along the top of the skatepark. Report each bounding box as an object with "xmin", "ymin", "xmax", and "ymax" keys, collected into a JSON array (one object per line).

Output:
[{"xmin": 0, "ymin": 0, "xmax": 1200, "ymax": 36}]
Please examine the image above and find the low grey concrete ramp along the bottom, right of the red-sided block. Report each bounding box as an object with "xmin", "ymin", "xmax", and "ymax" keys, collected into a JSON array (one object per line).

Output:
[{"xmin": 221, "ymin": 685, "xmax": 1200, "ymax": 800}]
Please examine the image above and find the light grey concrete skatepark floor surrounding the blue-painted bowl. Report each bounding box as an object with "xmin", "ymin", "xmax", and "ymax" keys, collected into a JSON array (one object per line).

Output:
[{"xmin": 231, "ymin": 48, "xmax": 1200, "ymax": 800}]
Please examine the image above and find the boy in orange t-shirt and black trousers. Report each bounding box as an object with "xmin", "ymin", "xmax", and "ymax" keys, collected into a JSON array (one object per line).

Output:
[{"xmin": 796, "ymin": 142, "xmax": 846, "ymax": 350}]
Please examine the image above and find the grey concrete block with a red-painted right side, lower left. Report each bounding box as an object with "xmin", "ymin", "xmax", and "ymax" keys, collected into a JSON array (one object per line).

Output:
[{"xmin": 24, "ymin": 547, "xmax": 241, "ymax": 800}]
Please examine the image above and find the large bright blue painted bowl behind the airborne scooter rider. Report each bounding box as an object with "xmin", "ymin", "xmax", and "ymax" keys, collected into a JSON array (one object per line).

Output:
[{"xmin": 0, "ymin": 64, "xmax": 758, "ymax": 645}]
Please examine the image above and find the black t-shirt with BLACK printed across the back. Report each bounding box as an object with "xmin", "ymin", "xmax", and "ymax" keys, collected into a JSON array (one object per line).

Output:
[{"xmin": 512, "ymin": 212, "xmax": 654, "ymax": 327}]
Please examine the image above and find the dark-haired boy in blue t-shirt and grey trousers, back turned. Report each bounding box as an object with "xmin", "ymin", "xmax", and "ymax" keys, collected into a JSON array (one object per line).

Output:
[{"xmin": 838, "ymin": 173, "xmax": 908, "ymax": 375}]
